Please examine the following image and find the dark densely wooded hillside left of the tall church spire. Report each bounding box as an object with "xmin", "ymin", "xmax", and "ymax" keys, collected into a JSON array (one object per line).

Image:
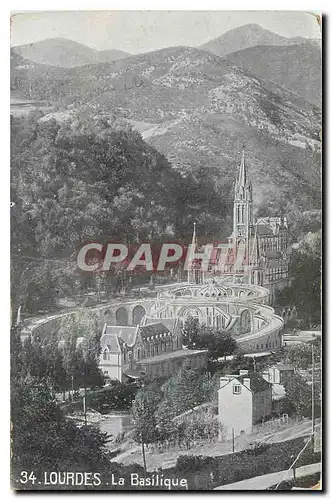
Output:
[{"xmin": 11, "ymin": 113, "xmax": 226, "ymax": 313}]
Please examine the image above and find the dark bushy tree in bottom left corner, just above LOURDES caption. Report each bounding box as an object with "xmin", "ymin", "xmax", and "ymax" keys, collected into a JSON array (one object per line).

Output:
[{"xmin": 11, "ymin": 380, "xmax": 109, "ymax": 479}]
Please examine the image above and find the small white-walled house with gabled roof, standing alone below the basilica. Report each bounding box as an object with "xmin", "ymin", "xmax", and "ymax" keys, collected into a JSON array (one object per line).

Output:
[{"xmin": 218, "ymin": 370, "xmax": 272, "ymax": 440}]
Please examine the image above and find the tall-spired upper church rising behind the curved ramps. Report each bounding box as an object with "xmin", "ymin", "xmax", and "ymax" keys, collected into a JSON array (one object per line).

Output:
[{"xmin": 210, "ymin": 149, "xmax": 289, "ymax": 301}]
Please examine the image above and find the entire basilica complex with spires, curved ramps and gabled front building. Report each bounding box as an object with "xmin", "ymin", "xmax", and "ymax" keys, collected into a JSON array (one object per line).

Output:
[{"xmin": 100, "ymin": 150, "xmax": 288, "ymax": 380}]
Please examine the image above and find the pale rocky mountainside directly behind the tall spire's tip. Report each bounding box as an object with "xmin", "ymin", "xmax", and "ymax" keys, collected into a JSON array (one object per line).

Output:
[{"xmin": 12, "ymin": 46, "xmax": 320, "ymax": 220}]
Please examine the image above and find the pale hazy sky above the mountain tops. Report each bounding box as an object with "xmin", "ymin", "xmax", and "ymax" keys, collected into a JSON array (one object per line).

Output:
[{"xmin": 11, "ymin": 10, "xmax": 320, "ymax": 53}]
